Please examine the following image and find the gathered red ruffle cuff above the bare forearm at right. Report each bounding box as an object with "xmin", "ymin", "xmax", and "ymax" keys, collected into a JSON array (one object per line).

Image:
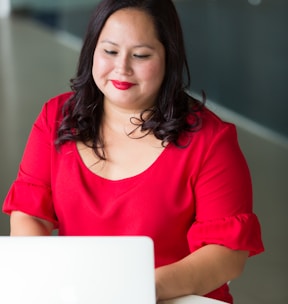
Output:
[{"xmin": 188, "ymin": 213, "xmax": 264, "ymax": 256}]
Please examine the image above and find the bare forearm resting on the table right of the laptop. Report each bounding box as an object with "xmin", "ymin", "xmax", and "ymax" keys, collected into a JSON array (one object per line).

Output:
[{"xmin": 155, "ymin": 245, "xmax": 248, "ymax": 300}]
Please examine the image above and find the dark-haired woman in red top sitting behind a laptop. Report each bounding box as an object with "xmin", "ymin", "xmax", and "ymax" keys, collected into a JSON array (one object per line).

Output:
[{"xmin": 3, "ymin": 0, "xmax": 263, "ymax": 303}]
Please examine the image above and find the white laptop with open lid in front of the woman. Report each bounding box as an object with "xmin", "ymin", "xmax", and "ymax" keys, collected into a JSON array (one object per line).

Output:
[{"xmin": 0, "ymin": 236, "xmax": 156, "ymax": 304}]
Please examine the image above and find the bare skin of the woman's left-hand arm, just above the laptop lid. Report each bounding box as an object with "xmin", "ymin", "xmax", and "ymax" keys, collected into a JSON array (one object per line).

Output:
[{"xmin": 10, "ymin": 211, "xmax": 53, "ymax": 236}]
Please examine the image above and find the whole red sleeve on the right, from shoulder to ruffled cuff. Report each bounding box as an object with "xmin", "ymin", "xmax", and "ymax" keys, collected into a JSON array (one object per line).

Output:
[{"xmin": 188, "ymin": 123, "xmax": 263, "ymax": 255}]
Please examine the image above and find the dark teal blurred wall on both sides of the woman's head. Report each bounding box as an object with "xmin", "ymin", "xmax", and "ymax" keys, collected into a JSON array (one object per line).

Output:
[{"xmin": 16, "ymin": 0, "xmax": 288, "ymax": 137}]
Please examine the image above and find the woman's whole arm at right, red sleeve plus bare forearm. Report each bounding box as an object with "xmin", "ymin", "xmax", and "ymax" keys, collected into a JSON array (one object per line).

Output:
[{"xmin": 155, "ymin": 120, "xmax": 263, "ymax": 300}]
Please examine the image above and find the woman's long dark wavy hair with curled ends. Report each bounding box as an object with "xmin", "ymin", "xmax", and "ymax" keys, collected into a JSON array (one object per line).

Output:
[{"xmin": 56, "ymin": 0, "xmax": 205, "ymax": 159}]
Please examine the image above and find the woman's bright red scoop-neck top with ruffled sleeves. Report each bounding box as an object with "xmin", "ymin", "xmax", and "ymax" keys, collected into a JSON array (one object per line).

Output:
[{"xmin": 3, "ymin": 93, "xmax": 263, "ymax": 302}]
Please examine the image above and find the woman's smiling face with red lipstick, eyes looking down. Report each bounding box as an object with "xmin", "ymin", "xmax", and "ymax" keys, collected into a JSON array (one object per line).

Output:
[{"xmin": 92, "ymin": 9, "xmax": 165, "ymax": 113}]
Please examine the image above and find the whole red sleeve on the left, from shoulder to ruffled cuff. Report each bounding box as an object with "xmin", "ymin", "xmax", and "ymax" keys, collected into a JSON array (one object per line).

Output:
[{"xmin": 3, "ymin": 99, "xmax": 57, "ymax": 226}]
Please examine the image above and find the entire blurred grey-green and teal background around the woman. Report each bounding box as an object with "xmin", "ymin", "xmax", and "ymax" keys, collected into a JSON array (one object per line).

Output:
[{"xmin": 0, "ymin": 0, "xmax": 288, "ymax": 304}]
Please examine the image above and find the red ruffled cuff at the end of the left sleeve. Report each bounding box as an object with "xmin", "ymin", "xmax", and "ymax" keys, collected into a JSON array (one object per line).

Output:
[{"xmin": 2, "ymin": 181, "xmax": 58, "ymax": 228}]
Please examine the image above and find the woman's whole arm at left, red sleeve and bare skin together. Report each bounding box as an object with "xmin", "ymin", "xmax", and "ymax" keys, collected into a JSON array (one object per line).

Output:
[{"xmin": 2, "ymin": 97, "xmax": 61, "ymax": 235}]
